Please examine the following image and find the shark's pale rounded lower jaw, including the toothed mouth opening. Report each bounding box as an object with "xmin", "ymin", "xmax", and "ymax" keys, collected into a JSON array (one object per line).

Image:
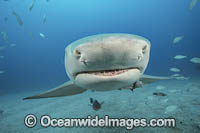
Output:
[{"xmin": 74, "ymin": 67, "xmax": 143, "ymax": 91}]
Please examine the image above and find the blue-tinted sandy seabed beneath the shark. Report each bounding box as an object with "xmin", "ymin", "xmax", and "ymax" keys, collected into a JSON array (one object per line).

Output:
[{"xmin": 0, "ymin": 78, "xmax": 200, "ymax": 133}]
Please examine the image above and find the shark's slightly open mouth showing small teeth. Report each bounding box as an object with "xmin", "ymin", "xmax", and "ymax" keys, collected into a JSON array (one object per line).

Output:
[{"xmin": 75, "ymin": 67, "xmax": 141, "ymax": 77}]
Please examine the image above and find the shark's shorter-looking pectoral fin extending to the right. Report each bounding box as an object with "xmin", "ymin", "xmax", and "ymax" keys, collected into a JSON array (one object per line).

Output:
[{"xmin": 140, "ymin": 74, "xmax": 172, "ymax": 85}]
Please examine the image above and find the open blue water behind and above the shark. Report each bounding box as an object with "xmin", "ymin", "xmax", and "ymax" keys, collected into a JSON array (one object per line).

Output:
[{"xmin": 0, "ymin": 0, "xmax": 200, "ymax": 132}]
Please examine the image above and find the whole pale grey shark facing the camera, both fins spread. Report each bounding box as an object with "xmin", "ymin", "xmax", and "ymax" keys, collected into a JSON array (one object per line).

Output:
[{"xmin": 24, "ymin": 33, "xmax": 169, "ymax": 99}]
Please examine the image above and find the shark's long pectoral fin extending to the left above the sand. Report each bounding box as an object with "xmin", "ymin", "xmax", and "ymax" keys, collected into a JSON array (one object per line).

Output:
[{"xmin": 24, "ymin": 81, "xmax": 86, "ymax": 100}]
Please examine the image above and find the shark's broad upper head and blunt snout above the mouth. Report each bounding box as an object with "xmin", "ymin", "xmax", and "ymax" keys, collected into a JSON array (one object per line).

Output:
[{"xmin": 65, "ymin": 35, "xmax": 150, "ymax": 82}]
